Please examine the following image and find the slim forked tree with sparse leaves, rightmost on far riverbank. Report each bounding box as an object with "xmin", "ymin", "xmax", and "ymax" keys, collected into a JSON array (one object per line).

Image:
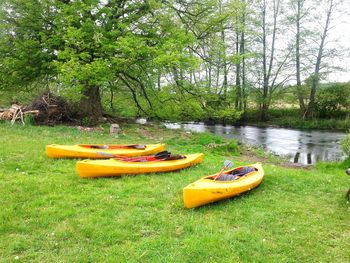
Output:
[{"xmin": 287, "ymin": 0, "xmax": 341, "ymax": 118}]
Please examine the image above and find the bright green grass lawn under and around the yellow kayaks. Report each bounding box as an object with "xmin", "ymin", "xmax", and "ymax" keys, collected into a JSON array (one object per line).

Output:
[{"xmin": 0, "ymin": 123, "xmax": 350, "ymax": 262}]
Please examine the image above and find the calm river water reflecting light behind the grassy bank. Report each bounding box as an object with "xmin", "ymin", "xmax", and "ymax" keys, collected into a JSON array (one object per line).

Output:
[{"xmin": 164, "ymin": 122, "xmax": 346, "ymax": 164}]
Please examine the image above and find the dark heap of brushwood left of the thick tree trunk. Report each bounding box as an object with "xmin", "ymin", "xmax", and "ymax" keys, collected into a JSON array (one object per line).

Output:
[{"xmin": 29, "ymin": 91, "xmax": 77, "ymax": 125}]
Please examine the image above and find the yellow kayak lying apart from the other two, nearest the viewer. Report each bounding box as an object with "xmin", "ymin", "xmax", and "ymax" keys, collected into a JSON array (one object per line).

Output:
[{"xmin": 183, "ymin": 163, "xmax": 264, "ymax": 208}]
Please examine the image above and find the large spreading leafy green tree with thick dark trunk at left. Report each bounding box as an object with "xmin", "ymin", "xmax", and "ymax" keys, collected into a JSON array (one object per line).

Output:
[{"xmin": 0, "ymin": 0, "xmax": 196, "ymax": 122}]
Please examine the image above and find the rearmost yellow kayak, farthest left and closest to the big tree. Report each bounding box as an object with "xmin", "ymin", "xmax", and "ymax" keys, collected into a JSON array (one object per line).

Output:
[{"xmin": 46, "ymin": 144, "xmax": 165, "ymax": 159}]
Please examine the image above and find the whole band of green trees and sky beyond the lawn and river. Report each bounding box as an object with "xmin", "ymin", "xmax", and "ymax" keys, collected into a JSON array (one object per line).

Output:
[{"xmin": 0, "ymin": 0, "xmax": 350, "ymax": 129}]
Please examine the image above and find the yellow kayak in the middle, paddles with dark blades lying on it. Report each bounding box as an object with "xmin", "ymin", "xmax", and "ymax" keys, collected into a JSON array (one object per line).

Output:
[{"xmin": 77, "ymin": 153, "xmax": 203, "ymax": 177}]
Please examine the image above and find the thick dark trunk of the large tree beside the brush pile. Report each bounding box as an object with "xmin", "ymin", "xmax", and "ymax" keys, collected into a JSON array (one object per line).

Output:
[{"xmin": 79, "ymin": 86, "xmax": 103, "ymax": 124}]
